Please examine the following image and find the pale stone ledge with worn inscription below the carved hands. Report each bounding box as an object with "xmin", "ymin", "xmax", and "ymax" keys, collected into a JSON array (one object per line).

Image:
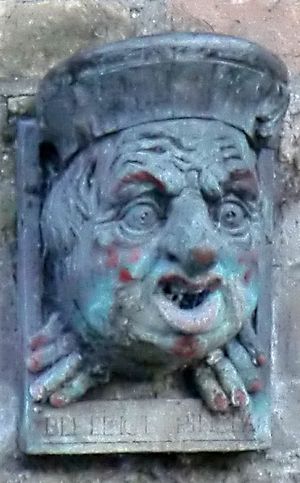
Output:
[{"xmin": 22, "ymin": 398, "xmax": 268, "ymax": 454}]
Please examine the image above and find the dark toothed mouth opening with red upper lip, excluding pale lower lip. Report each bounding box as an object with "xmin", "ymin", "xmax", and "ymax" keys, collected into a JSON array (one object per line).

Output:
[{"xmin": 158, "ymin": 275, "xmax": 220, "ymax": 310}]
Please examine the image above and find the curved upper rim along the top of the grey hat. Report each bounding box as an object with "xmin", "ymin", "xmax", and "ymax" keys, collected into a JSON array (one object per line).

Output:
[{"xmin": 41, "ymin": 32, "xmax": 288, "ymax": 89}]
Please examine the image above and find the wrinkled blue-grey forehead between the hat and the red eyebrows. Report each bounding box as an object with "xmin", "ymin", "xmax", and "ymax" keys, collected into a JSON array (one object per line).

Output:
[{"xmin": 111, "ymin": 119, "xmax": 256, "ymax": 175}]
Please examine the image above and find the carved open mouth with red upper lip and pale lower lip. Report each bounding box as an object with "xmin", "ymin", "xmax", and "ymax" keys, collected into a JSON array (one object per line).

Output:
[{"xmin": 155, "ymin": 274, "xmax": 221, "ymax": 334}]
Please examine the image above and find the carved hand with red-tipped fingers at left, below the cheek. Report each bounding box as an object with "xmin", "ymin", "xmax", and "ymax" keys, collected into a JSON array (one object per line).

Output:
[{"xmin": 27, "ymin": 313, "xmax": 109, "ymax": 407}]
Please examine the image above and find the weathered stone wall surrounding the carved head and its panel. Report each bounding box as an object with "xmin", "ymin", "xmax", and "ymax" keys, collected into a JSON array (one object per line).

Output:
[{"xmin": 0, "ymin": 0, "xmax": 300, "ymax": 483}]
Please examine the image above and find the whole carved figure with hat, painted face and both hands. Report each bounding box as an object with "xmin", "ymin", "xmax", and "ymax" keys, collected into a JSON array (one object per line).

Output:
[{"xmin": 27, "ymin": 34, "xmax": 288, "ymax": 412}]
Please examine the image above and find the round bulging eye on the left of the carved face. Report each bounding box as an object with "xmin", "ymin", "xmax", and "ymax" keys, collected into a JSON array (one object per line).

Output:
[{"xmin": 122, "ymin": 203, "xmax": 159, "ymax": 231}]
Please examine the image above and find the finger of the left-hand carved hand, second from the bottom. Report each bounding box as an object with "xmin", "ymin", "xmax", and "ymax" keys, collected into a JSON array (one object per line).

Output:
[{"xmin": 29, "ymin": 352, "xmax": 82, "ymax": 402}]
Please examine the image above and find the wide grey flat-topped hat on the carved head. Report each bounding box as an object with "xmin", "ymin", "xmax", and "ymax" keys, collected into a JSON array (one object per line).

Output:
[{"xmin": 37, "ymin": 33, "xmax": 288, "ymax": 166}]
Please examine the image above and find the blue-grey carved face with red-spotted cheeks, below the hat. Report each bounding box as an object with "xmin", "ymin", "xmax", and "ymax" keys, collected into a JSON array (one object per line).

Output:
[{"xmin": 42, "ymin": 120, "xmax": 261, "ymax": 370}]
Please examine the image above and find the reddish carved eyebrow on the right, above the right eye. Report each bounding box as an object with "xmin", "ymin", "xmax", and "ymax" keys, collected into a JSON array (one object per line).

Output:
[{"xmin": 224, "ymin": 169, "xmax": 259, "ymax": 199}]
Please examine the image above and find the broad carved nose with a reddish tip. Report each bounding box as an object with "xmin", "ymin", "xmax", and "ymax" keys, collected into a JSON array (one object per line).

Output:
[{"xmin": 161, "ymin": 194, "xmax": 219, "ymax": 275}]
